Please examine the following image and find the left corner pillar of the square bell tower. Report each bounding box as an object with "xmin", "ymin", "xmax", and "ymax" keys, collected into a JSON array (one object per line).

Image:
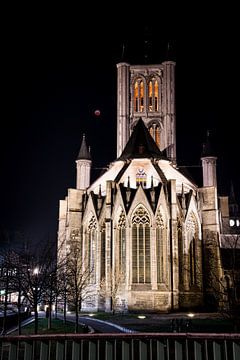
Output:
[{"xmin": 117, "ymin": 63, "xmax": 130, "ymax": 158}]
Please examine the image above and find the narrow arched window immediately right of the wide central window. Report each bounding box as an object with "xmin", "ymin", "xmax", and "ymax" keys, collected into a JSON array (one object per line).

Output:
[{"xmin": 156, "ymin": 210, "xmax": 166, "ymax": 283}]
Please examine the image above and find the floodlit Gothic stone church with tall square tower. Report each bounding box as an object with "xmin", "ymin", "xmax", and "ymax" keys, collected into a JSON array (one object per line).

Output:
[{"xmin": 58, "ymin": 61, "xmax": 240, "ymax": 312}]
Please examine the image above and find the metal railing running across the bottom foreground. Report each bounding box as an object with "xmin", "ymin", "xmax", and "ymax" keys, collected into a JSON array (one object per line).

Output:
[{"xmin": 0, "ymin": 333, "xmax": 240, "ymax": 360}]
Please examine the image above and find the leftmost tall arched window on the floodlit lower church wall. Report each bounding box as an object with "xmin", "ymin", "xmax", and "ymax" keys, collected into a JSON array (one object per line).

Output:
[{"xmin": 86, "ymin": 215, "xmax": 97, "ymax": 284}]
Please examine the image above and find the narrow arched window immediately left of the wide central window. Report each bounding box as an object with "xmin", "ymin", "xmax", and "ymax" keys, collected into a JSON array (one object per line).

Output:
[{"xmin": 116, "ymin": 210, "xmax": 126, "ymax": 279}]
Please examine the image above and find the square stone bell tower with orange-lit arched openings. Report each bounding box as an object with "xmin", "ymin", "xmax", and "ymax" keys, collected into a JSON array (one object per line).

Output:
[{"xmin": 117, "ymin": 61, "xmax": 176, "ymax": 163}]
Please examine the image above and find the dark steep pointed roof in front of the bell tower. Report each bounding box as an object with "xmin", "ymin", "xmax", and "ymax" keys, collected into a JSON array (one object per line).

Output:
[{"xmin": 117, "ymin": 118, "xmax": 166, "ymax": 160}]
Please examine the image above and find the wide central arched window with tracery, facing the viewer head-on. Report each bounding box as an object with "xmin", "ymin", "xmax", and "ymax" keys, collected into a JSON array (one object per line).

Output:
[{"xmin": 132, "ymin": 206, "xmax": 151, "ymax": 284}]
